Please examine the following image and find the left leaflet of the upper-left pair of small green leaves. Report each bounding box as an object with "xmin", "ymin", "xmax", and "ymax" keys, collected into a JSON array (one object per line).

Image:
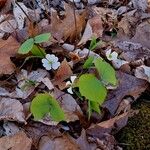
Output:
[{"xmin": 18, "ymin": 38, "xmax": 34, "ymax": 54}]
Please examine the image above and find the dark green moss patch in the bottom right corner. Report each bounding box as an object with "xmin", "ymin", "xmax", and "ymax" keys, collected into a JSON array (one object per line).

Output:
[{"xmin": 116, "ymin": 102, "xmax": 150, "ymax": 150}]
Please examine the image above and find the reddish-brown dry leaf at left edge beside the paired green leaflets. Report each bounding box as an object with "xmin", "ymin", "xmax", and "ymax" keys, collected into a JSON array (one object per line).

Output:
[{"xmin": 0, "ymin": 36, "xmax": 20, "ymax": 75}]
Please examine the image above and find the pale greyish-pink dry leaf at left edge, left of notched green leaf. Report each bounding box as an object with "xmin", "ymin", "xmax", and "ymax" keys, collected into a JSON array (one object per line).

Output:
[{"xmin": 0, "ymin": 98, "xmax": 26, "ymax": 123}]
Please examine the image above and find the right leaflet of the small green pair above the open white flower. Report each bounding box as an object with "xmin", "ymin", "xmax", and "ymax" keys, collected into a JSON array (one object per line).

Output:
[{"xmin": 34, "ymin": 33, "xmax": 51, "ymax": 44}]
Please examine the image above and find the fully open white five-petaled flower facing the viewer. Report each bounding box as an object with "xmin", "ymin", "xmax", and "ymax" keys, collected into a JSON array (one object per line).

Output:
[{"xmin": 42, "ymin": 54, "xmax": 60, "ymax": 70}]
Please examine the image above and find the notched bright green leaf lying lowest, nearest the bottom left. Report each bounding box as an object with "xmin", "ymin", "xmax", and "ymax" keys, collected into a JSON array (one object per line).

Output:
[{"xmin": 31, "ymin": 93, "xmax": 65, "ymax": 121}]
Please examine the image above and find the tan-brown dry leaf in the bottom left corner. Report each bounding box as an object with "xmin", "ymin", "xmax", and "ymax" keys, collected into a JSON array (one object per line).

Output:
[{"xmin": 0, "ymin": 131, "xmax": 32, "ymax": 150}]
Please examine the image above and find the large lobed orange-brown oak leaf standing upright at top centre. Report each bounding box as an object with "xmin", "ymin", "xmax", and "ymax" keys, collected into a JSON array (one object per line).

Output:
[{"xmin": 43, "ymin": 4, "xmax": 86, "ymax": 41}]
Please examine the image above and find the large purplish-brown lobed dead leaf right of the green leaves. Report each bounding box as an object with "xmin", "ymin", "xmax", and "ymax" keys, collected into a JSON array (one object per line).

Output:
[{"xmin": 102, "ymin": 72, "xmax": 148, "ymax": 116}]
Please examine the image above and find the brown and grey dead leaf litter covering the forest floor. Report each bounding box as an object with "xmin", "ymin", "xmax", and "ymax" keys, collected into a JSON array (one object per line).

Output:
[{"xmin": 0, "ymin": 0, "xmax": 150, "ymax": 150}]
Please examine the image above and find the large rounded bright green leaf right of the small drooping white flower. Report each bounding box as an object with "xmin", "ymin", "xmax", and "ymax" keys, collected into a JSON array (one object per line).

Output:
[{"xmin": 78, "ymin": 74, "xmax": 107, "ymax": 104}]
